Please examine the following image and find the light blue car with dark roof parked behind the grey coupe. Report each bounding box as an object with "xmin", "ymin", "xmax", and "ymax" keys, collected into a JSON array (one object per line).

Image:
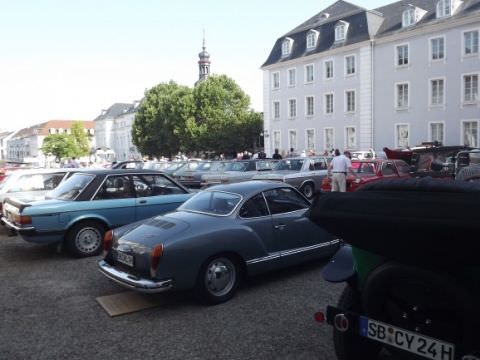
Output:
[{"xmin": 1, "ymin": 169, "xmax": 192, "ymax": 257}]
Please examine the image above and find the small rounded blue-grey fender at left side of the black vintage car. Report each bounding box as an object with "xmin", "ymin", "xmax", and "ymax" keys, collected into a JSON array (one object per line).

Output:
[{"xmin": 322, "ymin": 245, "xmax": 356, "ymax": 283}]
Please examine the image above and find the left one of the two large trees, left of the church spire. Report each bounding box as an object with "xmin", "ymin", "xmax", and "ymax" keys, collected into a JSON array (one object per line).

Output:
[{"xmin": 132, "ymin": 81, "xmax": 195, "ymax": 157}]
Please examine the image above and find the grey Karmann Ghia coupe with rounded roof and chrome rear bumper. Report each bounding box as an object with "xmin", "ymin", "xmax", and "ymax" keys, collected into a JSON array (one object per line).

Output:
[{"xmin": 98, "ymin": 181, "xmax": 340, "ymax": 304}]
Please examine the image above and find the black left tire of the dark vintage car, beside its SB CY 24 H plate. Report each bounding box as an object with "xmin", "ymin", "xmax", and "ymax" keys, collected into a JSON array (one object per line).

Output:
[{"xmin": 333, "ymin": 285, "xmax": 382, "ymax": 360}]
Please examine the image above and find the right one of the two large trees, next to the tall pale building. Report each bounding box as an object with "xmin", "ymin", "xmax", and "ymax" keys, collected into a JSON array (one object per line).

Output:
[{"xmin": 190, "ymin": 75, "xmax": 262, "ymax": 152}]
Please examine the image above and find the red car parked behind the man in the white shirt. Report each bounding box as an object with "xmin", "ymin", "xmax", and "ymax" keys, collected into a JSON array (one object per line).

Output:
[{"xmin": 322, "ymin": 159, "xmax": 412, "ymax": 191}]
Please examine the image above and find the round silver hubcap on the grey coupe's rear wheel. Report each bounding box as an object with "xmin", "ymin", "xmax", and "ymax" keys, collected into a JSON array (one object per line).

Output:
[{"xmin": 205, "ymin": 258, "xmax": 236, "ymax": 296}]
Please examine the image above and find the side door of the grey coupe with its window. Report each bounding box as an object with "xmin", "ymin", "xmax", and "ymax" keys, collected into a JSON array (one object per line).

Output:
[{"xmin": 264, "ymin": 188, "xmax": 334, "ymax": 266}]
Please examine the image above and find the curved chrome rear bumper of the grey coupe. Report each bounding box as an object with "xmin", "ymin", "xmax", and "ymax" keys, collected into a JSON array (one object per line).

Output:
[{"xmin": 98, "ymin": 260, "xmax": 173, "ymax": 293}]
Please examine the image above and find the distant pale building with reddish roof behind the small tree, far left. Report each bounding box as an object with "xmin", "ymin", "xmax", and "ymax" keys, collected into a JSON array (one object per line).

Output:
[{"xmin": 7, "ymin": 120, "xmax": 95, "ymax": 166}]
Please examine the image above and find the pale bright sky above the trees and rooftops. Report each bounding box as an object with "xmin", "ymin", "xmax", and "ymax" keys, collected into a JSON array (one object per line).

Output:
[{"xmin": 0, "ymin": 0, "xmax": 392, "ymax": 130}]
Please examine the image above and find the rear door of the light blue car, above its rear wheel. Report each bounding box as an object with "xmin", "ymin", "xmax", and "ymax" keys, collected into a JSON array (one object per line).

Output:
[{"xmin": 91, "ymin": 175, "xmax": 135, "ymax": 227}]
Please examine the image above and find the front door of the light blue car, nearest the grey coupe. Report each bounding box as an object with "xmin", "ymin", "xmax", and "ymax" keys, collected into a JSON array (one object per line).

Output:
[{"xmin": 132, "ymin": 173, "xmax": 191, "ymax": 220}]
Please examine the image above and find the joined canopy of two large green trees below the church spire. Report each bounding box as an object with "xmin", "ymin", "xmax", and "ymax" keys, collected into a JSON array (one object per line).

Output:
[{"xmin": 132, "ymin": 75, "xmax": 263, "ymax": 156}]
